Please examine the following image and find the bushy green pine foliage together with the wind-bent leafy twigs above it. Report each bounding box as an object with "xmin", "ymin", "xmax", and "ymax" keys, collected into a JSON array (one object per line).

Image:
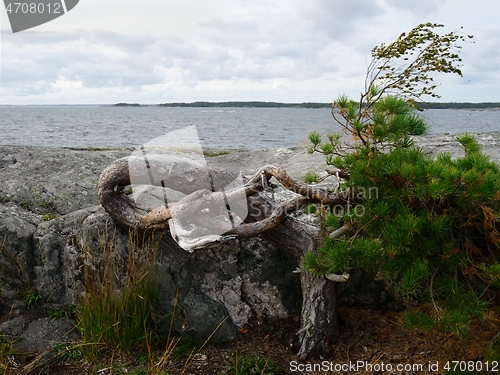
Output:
[{"xmin": 304, "ymin": 24, "xmax": 500, "ymax": 335}]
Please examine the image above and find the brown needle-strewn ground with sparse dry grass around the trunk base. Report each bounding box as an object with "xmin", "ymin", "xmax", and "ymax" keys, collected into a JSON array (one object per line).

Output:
[{"xmin": 19, "ymin": 309, "xmax": 500, "ymax": 375}]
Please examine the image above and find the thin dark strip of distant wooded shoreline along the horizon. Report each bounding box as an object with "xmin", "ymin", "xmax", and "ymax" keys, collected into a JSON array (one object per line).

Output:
[{"xmin": 113, "ymin": 101, "xmax": 500, "ymax": 109}]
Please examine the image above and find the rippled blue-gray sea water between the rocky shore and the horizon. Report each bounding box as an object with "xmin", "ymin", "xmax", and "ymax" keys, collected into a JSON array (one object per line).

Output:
[{"xmin": 0, "ymin": 105, "xmax": 500, "ymax": 150}]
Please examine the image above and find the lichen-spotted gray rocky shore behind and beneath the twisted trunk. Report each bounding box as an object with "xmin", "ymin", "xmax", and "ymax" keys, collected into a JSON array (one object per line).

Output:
[{"xmin": 0, "ymin": 132, "xmax": 500, "ymax": 370}]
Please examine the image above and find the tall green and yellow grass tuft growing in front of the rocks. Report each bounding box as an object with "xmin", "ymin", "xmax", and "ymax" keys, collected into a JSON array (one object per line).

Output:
[{"xmin": 76, "ymin": 231, "xmax": 159, "ymax": 355}]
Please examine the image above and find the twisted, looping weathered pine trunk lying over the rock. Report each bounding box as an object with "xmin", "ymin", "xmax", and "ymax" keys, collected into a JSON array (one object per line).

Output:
[{"xmin": 98, "ymin": 155, "xmax": 353, "ymax": 360}]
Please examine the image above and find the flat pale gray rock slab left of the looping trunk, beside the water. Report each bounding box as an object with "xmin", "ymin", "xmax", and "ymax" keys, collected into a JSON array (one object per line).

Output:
[{"xmin": 0, "ymin": 146, "xmax": 131, "ymax": 215}]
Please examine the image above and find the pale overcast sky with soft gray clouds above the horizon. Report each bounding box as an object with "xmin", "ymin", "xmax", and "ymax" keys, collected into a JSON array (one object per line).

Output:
[{"xmin": 0, "ymin": 0, "xmax": 500, "ymax": 104}]
